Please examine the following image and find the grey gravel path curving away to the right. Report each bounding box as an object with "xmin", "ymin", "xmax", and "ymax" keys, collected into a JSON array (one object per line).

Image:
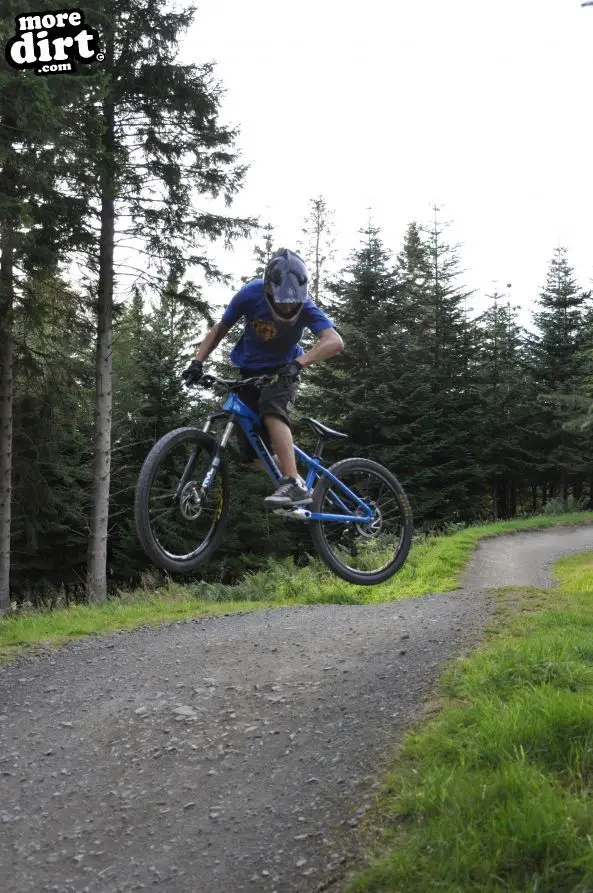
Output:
[{"xmin": 0, "ymin": 527, "xmax": 593, "ymax": 893}]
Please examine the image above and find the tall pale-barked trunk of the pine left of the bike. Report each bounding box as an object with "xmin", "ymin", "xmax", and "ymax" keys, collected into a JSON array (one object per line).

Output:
[{"xmin": 87, "ymin": 83, "xmax": 115, "ymax": 602}]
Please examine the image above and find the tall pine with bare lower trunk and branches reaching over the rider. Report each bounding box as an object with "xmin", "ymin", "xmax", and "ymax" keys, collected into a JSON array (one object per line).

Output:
[{"xmin": 80, "ymin": 0, "xmax": 253, "ymax": 600}]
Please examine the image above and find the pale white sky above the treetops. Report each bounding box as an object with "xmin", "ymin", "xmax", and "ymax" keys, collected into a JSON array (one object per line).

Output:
[{"xmin": 177, "ymin": 0, "xmax": 593, "ymax": 323}]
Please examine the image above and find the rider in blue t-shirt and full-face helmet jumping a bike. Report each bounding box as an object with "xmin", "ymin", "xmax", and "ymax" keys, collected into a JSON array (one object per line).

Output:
[{"xmin": 182, "ymin": 248, "xmax": 344, "ymax": 507}]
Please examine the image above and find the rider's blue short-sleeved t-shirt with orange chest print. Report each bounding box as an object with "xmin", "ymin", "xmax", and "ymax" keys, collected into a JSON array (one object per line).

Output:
[{"xmin": 222, "ymin": 279, "xmax": 335, "ymax": 370}]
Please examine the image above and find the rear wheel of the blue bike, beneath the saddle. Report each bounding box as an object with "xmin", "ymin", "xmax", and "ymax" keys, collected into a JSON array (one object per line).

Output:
[{"xmin": 310, "ymin": 459, "xmax": 414, "ymax": 586}]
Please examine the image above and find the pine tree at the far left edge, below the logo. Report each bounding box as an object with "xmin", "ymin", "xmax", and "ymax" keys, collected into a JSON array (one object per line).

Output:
[{"xmin": 0, "ymin": 0, "xmax": 89, "ymax": 612}]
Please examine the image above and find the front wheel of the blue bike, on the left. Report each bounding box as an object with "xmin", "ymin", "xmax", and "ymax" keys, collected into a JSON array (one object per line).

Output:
[{"xmin": 134, "ymin": 428, "xmax": 230, "ymax": 574}]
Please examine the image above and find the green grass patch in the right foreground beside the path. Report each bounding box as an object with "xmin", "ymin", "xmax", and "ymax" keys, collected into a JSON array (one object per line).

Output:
[{"xmin": 344, "ymin": 553, "xmax": 593, "ymax": 893}]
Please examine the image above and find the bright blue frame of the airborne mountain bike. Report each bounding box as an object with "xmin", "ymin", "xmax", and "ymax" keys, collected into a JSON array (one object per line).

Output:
[{"xmin": 201, "ymin": 392, "xmax": 374, "ymax": 524}]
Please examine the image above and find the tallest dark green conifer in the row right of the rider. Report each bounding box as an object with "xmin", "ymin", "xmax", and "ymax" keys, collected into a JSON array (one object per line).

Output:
[{"xmin": 388, "ymin": 215, "xmax": 481, "ymax": 522}]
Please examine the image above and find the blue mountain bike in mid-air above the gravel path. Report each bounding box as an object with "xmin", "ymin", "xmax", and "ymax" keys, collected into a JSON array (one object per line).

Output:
[{"xmin": 135, "ymin": 375, "xmax": 414, "ymax": 585}]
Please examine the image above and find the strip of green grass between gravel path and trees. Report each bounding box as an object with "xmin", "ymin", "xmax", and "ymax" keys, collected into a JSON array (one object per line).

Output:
[{"xmin": 0, "ymin": 512, "xmax": 593, "ymax": 660}]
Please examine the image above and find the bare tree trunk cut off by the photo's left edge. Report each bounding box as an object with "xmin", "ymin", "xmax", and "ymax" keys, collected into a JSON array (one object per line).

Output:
[{"xmin": 0, "ymin": 218, "xmax": 14, "ymax": 614}]
